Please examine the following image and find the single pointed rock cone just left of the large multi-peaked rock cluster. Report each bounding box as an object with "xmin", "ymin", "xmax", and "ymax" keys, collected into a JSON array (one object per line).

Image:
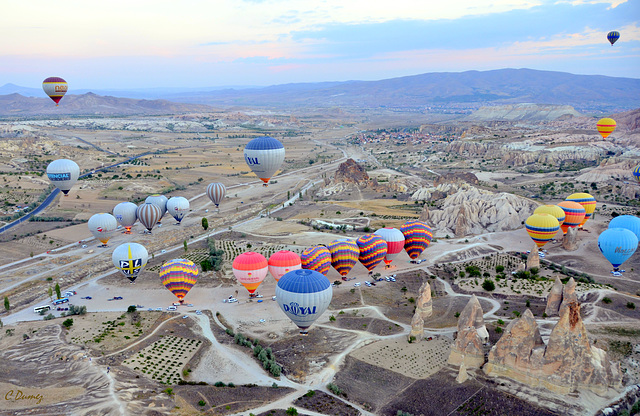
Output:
[{"xmin": 449, "ymin": 295, "xmax": 489, "ymax": 368}]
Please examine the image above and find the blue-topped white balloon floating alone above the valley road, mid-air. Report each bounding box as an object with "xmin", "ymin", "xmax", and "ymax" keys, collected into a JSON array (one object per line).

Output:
[{"xmin": 244, "ymin": 136, "xmax": 284, "ymax": 186}]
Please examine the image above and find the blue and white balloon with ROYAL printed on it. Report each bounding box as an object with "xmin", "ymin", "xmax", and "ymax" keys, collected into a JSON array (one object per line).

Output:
[{"xmin": 276, "ymin": 270, "xmax": 333, "ymax": 335}]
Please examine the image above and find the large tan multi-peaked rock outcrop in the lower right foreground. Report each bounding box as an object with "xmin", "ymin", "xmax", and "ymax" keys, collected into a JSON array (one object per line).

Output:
[{"xmin": 484, "ymin": 301, "xmax": 622, "ymax": 394}]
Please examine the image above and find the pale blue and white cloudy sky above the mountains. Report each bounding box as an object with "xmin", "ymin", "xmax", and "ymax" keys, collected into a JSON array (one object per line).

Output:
[{"xmin": 0, "ymin": 0, "xmax": 640, "ymax": 91}]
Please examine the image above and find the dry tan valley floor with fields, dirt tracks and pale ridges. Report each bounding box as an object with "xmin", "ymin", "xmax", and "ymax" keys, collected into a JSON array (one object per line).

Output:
[{"xmin": 0, "ymin": 109, "xmax": 640, "ymax": 416}]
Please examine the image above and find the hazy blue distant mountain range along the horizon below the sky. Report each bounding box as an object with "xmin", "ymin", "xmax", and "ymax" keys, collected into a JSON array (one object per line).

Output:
[{"xmin": 0, "ymin": 69, "xmax": 640, "ymax": 115}]
